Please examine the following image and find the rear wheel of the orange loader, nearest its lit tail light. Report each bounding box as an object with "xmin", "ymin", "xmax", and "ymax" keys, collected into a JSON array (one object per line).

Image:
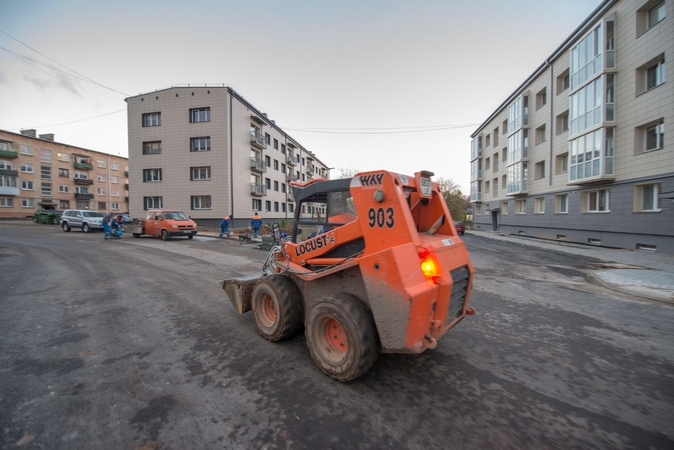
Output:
[{"xmin": 304, "ymin": 292, "xmax": 379, "ymax": 382}]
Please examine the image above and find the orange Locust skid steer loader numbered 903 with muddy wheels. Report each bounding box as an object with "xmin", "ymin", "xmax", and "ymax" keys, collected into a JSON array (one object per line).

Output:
[{"xmin": 220, "ymin": 171, "xmax": 475, "ymax": 381}]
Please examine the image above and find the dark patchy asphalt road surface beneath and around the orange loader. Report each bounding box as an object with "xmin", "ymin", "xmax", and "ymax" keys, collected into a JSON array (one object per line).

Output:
[{"xmin": 0, "ymin": 222, "xmax": 674, "ymax": 450}]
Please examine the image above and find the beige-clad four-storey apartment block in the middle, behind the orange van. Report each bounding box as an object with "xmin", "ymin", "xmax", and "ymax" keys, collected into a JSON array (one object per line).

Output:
[{"xmin": 126, "ymin": 85, "xmax": 329, "ymax": 227}]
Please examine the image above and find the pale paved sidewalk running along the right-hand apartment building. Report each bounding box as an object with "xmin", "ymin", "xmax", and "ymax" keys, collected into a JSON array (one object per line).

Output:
[{"xmin": 466, "ymin": 230, "xmax": 674, "ymax": 305}]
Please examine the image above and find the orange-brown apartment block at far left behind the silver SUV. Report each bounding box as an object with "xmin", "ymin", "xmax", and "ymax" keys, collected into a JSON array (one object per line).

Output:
[{"xmin": 0, "ymin": 130, "xmax": 129, "ymax": 218}]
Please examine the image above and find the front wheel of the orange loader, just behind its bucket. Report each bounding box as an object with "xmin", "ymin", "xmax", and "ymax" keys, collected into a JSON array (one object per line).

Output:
[{"xmin": 251, "ymin": 275, "xmax": 304, "ymax": 342}]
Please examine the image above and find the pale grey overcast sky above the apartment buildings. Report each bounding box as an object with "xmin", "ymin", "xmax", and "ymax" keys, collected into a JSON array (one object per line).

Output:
[{"xmin": 0, "ymin": 0, "xmax": 601, "ymax": 194}]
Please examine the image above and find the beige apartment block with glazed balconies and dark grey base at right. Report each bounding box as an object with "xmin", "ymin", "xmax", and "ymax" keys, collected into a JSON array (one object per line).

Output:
[{"xmin": 470, "ymin": 0, "xmax": 674, "ymax": 253}]
